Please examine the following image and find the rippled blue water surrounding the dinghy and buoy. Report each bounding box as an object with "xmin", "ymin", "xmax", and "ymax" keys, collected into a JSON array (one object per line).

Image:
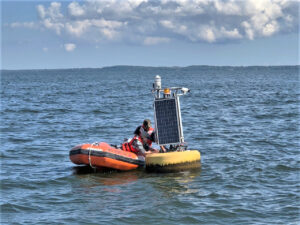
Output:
[{"xmin": 0, "ymin": 66, "xmax": 300, "ymax": 224}]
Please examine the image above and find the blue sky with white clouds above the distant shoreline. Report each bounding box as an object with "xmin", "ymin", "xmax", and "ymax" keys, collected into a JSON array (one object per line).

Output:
[{"xmin": 0, "ymin": 0, "xmax": 300, "ymax": 69}]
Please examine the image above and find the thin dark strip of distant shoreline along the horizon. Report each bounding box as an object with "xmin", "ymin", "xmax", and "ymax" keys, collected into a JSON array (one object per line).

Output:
[{"xmin": 0, "ymin": 65, "xmax": 300, "ymax": 72}]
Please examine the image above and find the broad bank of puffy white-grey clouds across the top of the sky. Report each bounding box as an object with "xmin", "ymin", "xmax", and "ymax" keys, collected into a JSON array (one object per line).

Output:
[{"xmin": 11, "ymin": 0, "xmax": 300, "ymax": 45}]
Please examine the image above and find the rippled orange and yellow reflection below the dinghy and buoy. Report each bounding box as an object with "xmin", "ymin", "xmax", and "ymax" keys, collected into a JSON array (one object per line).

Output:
[{"xmin": 73, "ymin": 166, "xmax": 201, "ymax": 196}]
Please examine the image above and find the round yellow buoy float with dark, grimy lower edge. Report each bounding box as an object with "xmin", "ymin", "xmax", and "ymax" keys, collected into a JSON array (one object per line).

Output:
[{"xmin": 146, "ymin": 150, "xmax": 201, "ymax": 172}]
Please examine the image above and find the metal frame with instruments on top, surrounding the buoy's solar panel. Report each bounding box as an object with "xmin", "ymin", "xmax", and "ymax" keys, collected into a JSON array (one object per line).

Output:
[{"xmin": 152, "ymin": 75, "xmax": 190, "ymax": 145}]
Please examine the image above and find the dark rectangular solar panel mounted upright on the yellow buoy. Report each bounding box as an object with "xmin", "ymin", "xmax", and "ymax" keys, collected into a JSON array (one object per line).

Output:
[{"xmin": 154, "ymin": 98, "xmax": 181, "ymax": 145}]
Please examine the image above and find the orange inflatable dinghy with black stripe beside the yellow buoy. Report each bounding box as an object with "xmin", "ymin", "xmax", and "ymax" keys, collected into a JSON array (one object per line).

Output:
[{"xmin": 70, "ymin": 142, "xmax": 145, "ymax": 170}]
